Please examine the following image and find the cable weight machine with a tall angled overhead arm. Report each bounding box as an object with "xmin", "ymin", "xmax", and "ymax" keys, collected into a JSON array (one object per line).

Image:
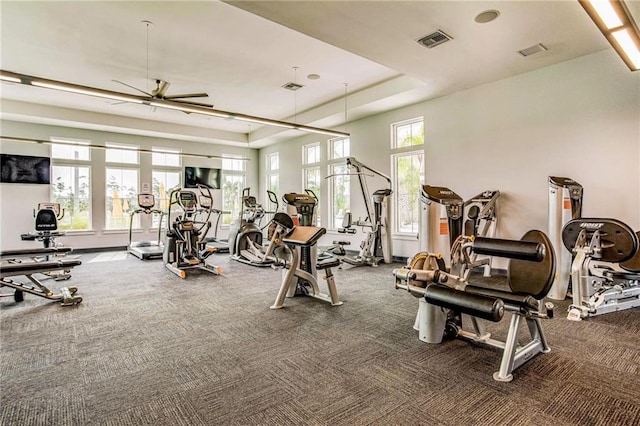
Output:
[{"xmin": 340, "ymin": 157, "xmax": 393, "ymax": 267}]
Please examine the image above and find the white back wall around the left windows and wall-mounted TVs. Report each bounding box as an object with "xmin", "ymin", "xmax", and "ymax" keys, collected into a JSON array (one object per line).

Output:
[{"xmin": 0, "ymin": 121, "xmax": 258, "ymax": 250}]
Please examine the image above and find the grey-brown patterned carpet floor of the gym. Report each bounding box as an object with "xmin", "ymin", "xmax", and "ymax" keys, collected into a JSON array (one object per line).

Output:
[{"xmin": 0, "ymin": 252, "xmax": 640, "ymax": 425}]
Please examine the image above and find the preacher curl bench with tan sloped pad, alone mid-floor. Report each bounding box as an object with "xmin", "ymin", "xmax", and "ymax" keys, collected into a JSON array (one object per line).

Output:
[{"xmin": 271, "ymin": 217, "xmax": 342, "ymax": 309}]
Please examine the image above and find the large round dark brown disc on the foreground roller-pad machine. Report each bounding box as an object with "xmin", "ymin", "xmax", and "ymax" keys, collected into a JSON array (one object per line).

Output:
[{"xmin": 508, "ymin": 230, "xmax": 556, "ymax": 300}]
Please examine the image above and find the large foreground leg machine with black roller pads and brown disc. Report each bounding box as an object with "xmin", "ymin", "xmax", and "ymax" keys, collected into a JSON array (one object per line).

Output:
[{"xmin": 394, "ymin": 231, "xmax": 556, "ymax": 382}]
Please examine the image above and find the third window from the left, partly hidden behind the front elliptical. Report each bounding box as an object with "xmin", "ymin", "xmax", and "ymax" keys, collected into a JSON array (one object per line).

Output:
[{"xmin": 151, "ymin": 148, "xmax": 182, "ymax": 227}]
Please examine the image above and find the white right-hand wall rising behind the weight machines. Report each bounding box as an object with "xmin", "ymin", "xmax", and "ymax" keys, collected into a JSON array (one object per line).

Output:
[{"xmin": 260, "ymin": 50, "xmax": 640, "ymax": 256}]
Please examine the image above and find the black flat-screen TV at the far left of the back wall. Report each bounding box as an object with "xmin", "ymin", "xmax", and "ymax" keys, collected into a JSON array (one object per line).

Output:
[{"xmin": 0, "ymin": 154, "xmax": 51, "ymax": 185}]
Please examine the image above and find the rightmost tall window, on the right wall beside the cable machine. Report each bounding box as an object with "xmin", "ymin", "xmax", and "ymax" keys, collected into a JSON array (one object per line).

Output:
[{"xmin": 391, "ymin": 118, "xmax": 424, "ymax": 234}]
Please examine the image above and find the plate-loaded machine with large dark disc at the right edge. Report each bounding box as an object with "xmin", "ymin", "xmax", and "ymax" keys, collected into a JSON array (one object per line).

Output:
[{"xmin": 562, "ymin": 218, "xmax": 640, "ymax": 321}]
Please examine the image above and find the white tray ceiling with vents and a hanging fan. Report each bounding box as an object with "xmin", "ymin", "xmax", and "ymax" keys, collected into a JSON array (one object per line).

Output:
[{"xmin": 0, "ymin": 0, "xmax": 624, "ymax": 148}]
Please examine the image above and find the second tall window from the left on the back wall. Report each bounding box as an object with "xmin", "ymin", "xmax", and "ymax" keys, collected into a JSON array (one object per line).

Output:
[{"xmin": 105, "ymin": 144, "xmax": 140, "ymax": 229}]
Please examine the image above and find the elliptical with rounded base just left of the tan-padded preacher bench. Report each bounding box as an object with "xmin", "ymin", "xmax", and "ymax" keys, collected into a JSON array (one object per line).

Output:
[{"xmin": 229, "ymin": 188, "xmax": 279, "ymax": 266}]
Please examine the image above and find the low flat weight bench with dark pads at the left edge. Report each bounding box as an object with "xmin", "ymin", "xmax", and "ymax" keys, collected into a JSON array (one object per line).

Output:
[{"xmin": 0, "ymin": 247, "xmax": 82, "ymax": 306}]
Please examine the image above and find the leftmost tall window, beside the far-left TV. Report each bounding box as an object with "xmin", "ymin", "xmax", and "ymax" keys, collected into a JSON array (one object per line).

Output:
[{"xmin": 51, "ymin": 138, "xmax": 91, "ymax": 230}]
